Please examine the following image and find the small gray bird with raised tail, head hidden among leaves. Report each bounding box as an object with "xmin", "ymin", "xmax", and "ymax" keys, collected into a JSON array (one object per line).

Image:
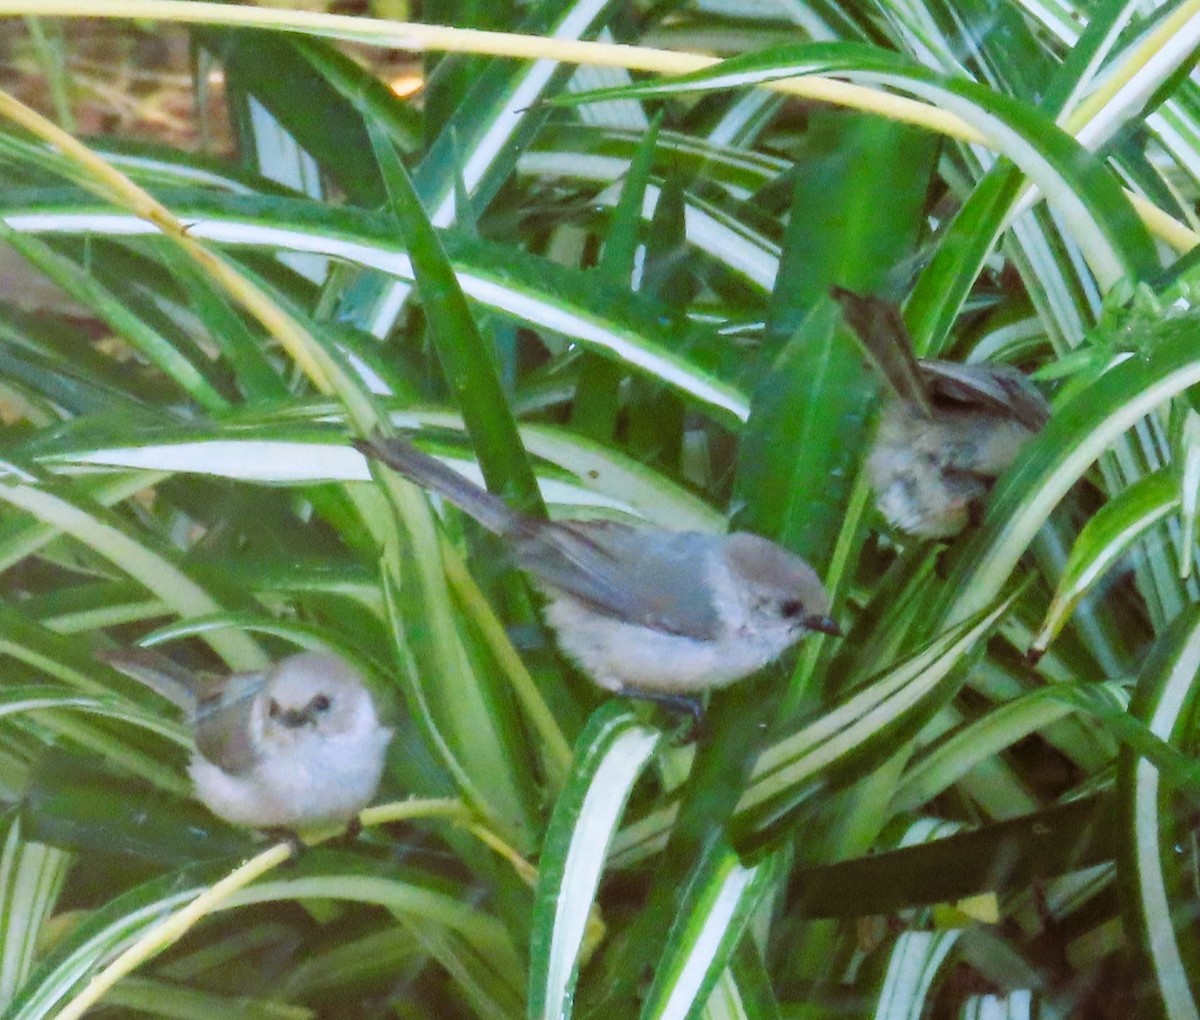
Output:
[{"xmin": 833, "ymin": 287, "xmax": 1050, "ymax": 539}]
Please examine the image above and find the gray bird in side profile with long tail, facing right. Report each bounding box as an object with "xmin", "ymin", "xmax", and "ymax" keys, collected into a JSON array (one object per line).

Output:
[{"xmin": 354, "ymin": 427, "xmax": 841, "ymax": 703}]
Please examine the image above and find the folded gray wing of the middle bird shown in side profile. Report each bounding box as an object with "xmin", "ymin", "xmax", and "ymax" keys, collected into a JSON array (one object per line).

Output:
[{"xmin": 516, "ymin": 521, "xmax": 720, "ymax": 641}]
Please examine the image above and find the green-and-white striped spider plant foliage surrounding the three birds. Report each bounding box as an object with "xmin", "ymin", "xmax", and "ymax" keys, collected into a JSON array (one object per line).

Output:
[{"xmin": 0, "ymin": 0, "xmax": 1200, "ymax": 1020}]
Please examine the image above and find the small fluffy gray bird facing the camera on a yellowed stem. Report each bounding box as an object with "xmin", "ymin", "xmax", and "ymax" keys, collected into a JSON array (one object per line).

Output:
[{"xmin": 100, "ymin": 648, "xmax": 391, "ymax": 832}]
